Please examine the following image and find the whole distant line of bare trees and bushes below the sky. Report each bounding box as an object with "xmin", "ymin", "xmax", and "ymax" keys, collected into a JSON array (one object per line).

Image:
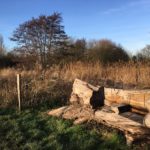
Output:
[{"xmin": 0, "ymin": 12, "xmax": 150, "ymax": 69}]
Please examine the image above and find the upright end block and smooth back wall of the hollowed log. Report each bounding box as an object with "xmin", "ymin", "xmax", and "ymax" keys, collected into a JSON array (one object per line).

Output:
[{"xmin": 70, "ymin": 79, "xmax": 150, "ymax": 112}]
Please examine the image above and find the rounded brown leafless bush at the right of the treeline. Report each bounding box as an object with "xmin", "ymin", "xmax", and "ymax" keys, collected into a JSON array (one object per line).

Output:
[{"xmin": 88, "ymin": 40, "xmax": 129, "ymax": 64}]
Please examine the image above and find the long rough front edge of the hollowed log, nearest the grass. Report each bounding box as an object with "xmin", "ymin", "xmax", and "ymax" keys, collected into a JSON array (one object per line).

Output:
[{"xmin": 94, "ymin": 110, "xmax": 150, "ymax": 145}]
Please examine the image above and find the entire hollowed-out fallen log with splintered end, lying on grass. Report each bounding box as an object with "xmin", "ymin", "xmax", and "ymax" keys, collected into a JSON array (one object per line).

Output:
[{"xmin": 48, "ymin": 79, "xmax": 150, "ymax": 144}]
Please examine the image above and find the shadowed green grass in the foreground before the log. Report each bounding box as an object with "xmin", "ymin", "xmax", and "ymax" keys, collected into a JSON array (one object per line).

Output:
[{"xmin": 0, "ymin": 106, "xmax": 147, "ymax": 150}]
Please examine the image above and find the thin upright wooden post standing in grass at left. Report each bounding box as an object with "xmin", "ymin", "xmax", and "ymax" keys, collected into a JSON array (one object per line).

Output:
[{"xmin": 17, "ymin": 74, "xmax": 21, "ymax": 111}]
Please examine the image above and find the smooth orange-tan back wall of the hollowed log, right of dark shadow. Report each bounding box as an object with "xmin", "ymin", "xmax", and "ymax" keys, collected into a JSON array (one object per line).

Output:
[{"xmin": 104, "ymin": 88, "xmax": 150, "ymax": 112}]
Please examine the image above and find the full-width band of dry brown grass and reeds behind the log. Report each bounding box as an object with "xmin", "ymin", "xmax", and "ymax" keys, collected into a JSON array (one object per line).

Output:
[{"xmin": 0, "ymin": 62, "xmax": 150, "ymax": 106}]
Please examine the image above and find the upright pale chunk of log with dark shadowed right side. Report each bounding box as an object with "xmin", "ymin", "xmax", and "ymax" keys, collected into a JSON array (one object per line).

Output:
[{"xmin": 70, "ymin": 79, "xmax": 104, "ymax": 108}]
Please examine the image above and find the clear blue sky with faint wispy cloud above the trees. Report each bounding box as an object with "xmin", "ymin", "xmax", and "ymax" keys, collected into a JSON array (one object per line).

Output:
[{"xmin": 0, "ymin": 0, "xmax": 150, "ymax": 53}]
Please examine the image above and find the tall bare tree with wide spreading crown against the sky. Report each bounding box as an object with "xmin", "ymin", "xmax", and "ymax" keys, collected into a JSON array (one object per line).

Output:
[{"xmin": 11, "ymin": 13, "xmax": 67, "ymax": 67}]
